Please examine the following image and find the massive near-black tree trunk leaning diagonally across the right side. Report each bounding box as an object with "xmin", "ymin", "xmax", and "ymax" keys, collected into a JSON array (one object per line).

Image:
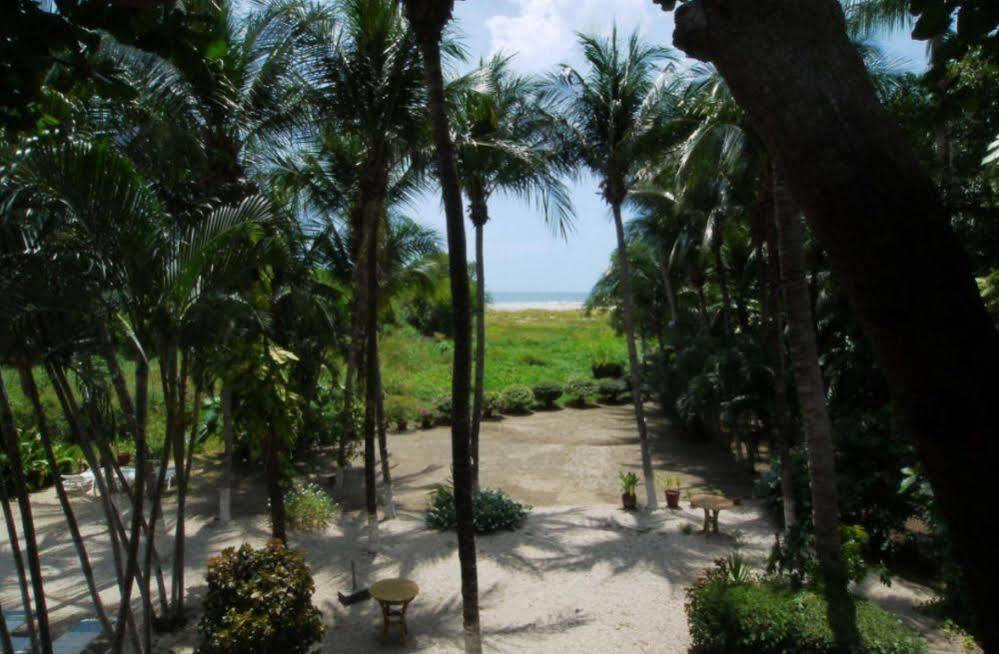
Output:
[{"xmin": 674, "ymin": 0, "xmax": 999, "ymax": 650}]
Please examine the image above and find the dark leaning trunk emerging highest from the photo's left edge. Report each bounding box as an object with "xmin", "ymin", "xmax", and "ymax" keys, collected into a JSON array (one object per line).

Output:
[{"xmin": 0, "ymin": 375, "xmax": 52, "ymax": 654}]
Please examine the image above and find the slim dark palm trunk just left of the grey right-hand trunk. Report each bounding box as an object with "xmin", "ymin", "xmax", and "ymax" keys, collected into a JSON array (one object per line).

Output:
[{"xmin": 763, "ymin": 199, "xmax": 797, "ymax": 529}]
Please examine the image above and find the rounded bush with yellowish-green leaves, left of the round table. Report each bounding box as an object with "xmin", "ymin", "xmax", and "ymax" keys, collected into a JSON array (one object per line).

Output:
[{"xmin": 198, "ymin": 540, "xmax": 323, "ymax": 654}]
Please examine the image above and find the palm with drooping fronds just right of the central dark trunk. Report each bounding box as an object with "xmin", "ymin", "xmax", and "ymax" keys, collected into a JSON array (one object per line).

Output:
[{"xmin": 452, "ymin": 55, "xmax": 572, "ymax": 492}]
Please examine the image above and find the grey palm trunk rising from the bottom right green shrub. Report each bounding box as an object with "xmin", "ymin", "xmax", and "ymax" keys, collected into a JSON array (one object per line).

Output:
[{"xmin": 774, "ymin": 161, "xmax": 860, "ymax": 651}]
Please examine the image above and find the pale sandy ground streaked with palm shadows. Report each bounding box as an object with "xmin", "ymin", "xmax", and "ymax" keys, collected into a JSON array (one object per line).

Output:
[{"xmin": 0, "ymin": 406, "xmax": 960, "ymax": 652}]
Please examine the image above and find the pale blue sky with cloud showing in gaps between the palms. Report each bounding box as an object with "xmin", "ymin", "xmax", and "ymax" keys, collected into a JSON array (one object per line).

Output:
[{"xmin": 410, "ymin": 0, "xmax": 925, "ymax": 292}]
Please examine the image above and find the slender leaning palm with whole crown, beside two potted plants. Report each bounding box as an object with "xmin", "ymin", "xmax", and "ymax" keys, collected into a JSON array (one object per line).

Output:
[{"xmin": 552, "ymin": 27, "xmax": 672, "ymax": 510}]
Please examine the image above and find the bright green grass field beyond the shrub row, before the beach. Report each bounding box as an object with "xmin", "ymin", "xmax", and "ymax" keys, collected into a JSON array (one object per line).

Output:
[{"xmin": 381, "ymin": 310, "xmax": 627, "ymax": 402}]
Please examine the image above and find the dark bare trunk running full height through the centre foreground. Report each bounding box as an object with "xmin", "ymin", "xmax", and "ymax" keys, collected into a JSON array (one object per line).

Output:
[{"xmin": 406, "ymin": 0, "xmax": 482, "ymax": 654}]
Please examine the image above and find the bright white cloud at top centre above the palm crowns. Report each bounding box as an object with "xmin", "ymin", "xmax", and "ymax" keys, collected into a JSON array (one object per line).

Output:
[{"xmin": 486, "ymin": 0, "xmax": 663, "ymax": 72}]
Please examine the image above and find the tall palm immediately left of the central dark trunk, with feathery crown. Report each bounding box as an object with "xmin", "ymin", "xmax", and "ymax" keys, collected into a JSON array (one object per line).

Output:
[{"xmin": 298, "ymin": 0, "xmax": 426, "ymax": 539}]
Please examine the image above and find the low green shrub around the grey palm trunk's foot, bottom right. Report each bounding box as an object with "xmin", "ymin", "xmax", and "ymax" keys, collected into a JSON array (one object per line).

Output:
[{"xmin": 685, "ymin": 557, "xmax": 925, "ymax": 654}]
